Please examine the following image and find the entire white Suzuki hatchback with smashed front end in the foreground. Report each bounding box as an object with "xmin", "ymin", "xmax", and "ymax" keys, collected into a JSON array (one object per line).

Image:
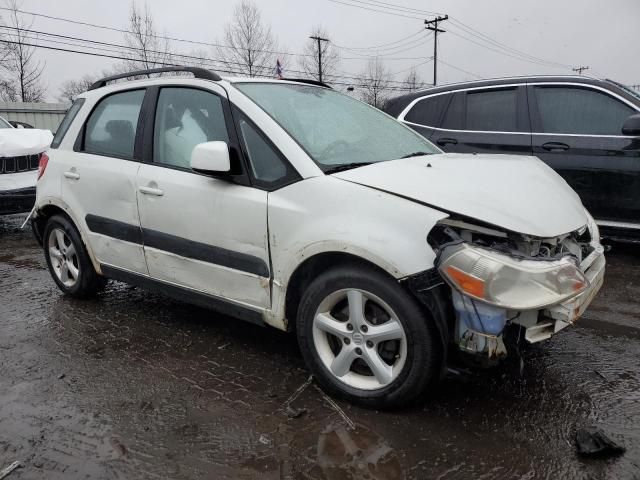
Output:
[{"xmin": 33, "ymin": 68, "xmax": 605, "ymax": 407}]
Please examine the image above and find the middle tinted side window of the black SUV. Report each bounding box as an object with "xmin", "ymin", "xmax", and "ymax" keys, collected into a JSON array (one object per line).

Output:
[{"xmin": 465, "ymin": 88, "xmax": 518, "ymax": 132}]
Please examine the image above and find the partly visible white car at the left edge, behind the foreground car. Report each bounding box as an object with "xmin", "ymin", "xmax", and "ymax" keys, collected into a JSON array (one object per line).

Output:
[{"xmin": 0, "ymin": 117, "xmax": 53, "ymax": 215}]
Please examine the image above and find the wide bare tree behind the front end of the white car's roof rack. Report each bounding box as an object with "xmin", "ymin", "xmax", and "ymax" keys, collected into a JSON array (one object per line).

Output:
[{"xmin": 218, "ymin": 0, "xmax": 277, "ymax": 77}]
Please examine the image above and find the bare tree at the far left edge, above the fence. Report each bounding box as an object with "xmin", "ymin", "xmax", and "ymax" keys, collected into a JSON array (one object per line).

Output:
[{"xmin": 0, "ymin": 0, "xmax": 46, "ymax": 102}]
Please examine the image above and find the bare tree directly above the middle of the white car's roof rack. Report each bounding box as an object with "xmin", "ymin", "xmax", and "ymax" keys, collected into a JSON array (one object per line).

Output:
[{"xmin": 123, "ymin": 1, "xmax": 173, "ymax": 71}]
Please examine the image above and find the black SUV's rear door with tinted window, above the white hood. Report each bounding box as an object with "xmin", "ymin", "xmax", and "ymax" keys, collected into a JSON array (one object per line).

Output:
[{"xmin": 424, "ymin": 86, "xmax": 531, "ymax": 155}]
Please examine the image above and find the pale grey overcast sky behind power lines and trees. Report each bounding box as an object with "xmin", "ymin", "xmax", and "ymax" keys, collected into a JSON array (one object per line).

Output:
[{"xmin": 5, "ymin": 0, "xmax": 640, "ymax": 100}]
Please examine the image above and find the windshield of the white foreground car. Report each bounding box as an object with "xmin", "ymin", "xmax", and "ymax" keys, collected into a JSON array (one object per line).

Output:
[{"xmin": 235, "ymin": 83, "xmax": 440, "ymax": 172}]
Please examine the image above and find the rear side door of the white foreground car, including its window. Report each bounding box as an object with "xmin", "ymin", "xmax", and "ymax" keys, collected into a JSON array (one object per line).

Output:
[{"xmin": 62, "ymin": 89, "xmax": 147, "ymax": 274}]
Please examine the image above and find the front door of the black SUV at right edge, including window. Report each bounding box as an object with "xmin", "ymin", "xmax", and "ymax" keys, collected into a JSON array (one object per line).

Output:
[{"xmin": 529, "ymin": 83, "xmax": 640, "ymax": 226}]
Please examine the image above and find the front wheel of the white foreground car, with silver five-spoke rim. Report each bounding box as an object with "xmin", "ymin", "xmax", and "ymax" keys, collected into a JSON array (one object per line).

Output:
[{"xmin": 296, "ymin": 266, "xmax": 443, "ymax": 408}]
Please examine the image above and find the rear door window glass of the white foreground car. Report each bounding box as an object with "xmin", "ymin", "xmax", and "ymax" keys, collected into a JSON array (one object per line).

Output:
[{"xmin": 83, "ymin": 90, "xmax": 145, "ymax": 158}]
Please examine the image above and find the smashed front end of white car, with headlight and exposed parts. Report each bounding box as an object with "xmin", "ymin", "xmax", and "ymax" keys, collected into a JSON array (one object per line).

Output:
[{"xmin": 428, "ymin": 216, "xmax": 605, "ymax": 359}]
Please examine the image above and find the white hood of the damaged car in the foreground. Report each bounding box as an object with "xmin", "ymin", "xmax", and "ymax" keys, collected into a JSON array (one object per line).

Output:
[{"xmin": 333, "ymin": 153, "xmax": 587, "ymax": 238}]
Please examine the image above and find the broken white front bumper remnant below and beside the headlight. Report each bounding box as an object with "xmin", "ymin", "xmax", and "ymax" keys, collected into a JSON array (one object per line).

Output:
[{"xmin": 514, "ymin": 245, "xmax": 606, "ymax": 343}]
